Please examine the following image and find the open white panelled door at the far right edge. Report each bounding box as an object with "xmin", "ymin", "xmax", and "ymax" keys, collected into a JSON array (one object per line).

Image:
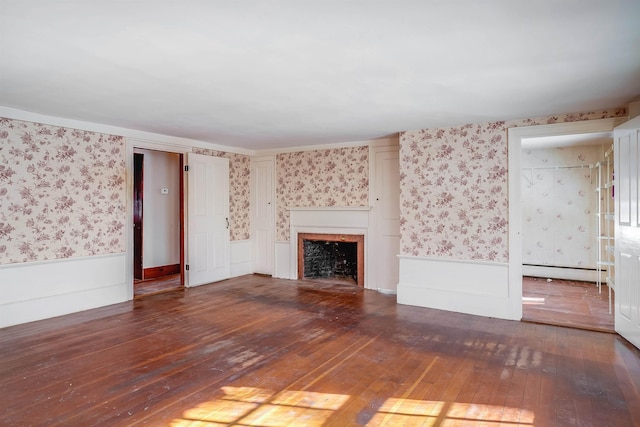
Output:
[{"xmin": 614, "ymin": 117, "xmax": 640, "ymax": 348}]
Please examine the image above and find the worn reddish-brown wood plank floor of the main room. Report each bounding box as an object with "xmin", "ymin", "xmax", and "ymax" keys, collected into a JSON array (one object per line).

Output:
[{"xmin": 0, "ymin": 275, "xmax": 640, "ymax": 427}]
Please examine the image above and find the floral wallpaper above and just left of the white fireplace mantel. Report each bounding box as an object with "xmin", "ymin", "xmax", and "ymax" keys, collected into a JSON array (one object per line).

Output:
[{"xmin": 276, "ymin": 146, "xmax": 369, "ymax": 241}]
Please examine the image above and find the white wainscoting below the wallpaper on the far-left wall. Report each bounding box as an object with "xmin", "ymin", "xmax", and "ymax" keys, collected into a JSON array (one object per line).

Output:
[{"xmin": 0, "ymin": 253, "xmax": 131, "ymax": 327}]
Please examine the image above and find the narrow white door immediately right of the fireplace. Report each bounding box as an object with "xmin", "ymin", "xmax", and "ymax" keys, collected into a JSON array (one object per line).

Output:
[{"xmin": 369, "ymin": 146, "xmax": 400, "ymax": 292}]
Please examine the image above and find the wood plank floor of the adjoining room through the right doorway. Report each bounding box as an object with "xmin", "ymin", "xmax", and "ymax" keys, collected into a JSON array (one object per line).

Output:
[{"xmin": 522, "ymin": 277, "xmax": 615, "ymax": 333}]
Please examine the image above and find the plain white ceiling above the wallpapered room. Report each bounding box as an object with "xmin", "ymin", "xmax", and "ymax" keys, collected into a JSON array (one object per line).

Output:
[{"xmin": 0, "ymin": 0, "xmax": 640, "ymax": 150}]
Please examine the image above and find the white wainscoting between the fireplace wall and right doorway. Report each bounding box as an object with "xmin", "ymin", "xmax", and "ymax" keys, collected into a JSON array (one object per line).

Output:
[{"xmin": 398, "ymin": 256, "xmax": 522, "ymax": 320}]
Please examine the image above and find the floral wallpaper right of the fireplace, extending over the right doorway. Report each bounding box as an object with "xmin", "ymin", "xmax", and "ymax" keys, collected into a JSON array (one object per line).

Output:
[{"xmin": 400, "ymin": 108, "xmax": 626, "ymax": 262}]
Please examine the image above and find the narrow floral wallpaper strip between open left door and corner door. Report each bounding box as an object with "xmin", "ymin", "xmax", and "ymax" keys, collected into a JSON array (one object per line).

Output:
[{"xmin": 193, "ymin": 148, "xmax": 251, "ymax": 241}]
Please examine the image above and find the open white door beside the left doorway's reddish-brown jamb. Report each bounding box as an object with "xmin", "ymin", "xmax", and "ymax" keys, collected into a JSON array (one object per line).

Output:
[{"xmin": 187, "ymin": 153, "xmax": 231, "ymax": 286}]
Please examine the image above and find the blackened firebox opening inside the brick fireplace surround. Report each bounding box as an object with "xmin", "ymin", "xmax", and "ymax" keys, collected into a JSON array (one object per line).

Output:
[{"xmin": 303, "ymin": 240, "xmax": 358, "ymax": 282}]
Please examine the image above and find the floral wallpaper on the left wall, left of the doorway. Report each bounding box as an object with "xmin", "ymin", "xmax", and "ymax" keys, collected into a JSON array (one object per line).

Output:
[{"xmin": 0, "ymin": 118, "xmax": 126, "ymax": 264}]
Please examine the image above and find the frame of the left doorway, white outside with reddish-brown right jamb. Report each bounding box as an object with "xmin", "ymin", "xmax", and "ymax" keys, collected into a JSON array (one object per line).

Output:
[{"xmin": 125, "ymin": 138, "xmax": 192, "ymax": 300}]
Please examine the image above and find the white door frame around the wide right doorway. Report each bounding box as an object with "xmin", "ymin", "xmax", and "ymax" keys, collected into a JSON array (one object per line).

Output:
[{"xmin": 507, "ymin": 116, "xmax": 627, "ymax": 319}]
